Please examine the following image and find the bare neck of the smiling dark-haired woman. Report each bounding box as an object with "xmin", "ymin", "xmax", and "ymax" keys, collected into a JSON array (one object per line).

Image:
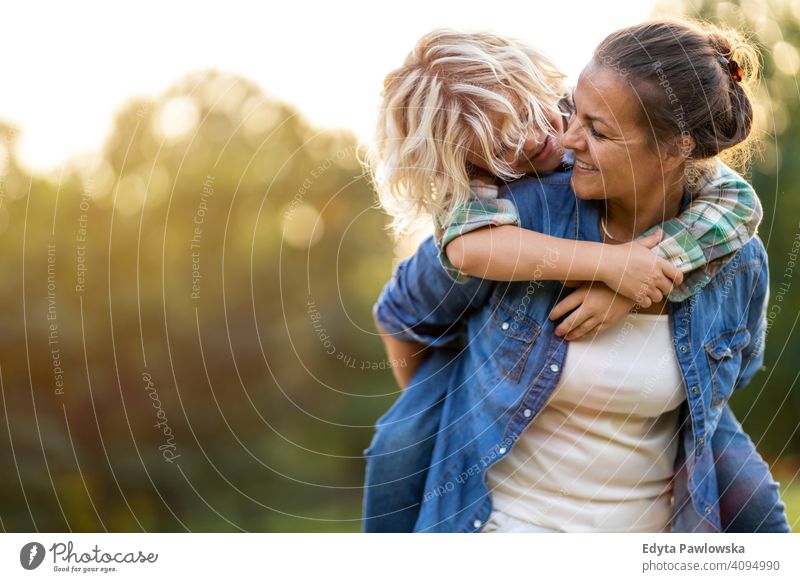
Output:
[{"xmin": 605, "ymin": 179, "xmax": 684, "ymax": 242}]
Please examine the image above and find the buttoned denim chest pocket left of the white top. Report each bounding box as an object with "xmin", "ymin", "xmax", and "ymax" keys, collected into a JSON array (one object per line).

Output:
[{"xmin": 490, "ymin": 299, "xmax": 541, "ymax": 383}]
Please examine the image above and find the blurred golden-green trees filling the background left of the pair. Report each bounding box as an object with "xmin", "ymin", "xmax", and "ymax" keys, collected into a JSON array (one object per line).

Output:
[{"xmin": 0, "ymin": 71, "xmax": 400, "ymax": 531}]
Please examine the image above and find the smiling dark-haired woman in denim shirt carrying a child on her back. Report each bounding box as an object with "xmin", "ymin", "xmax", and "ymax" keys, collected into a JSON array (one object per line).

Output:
[{"xmin": 368, "ymin": 23, "xmax": 788, "ymax": 531}]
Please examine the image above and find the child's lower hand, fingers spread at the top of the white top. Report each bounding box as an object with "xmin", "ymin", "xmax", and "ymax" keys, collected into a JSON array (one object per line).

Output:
[{"xmin": 550, "ymin": 283, "xmax": 635, "ymax": 341}]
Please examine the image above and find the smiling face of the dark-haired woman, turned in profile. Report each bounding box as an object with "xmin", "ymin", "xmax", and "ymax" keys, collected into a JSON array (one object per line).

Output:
[{"xmin": 562, "ymin": 63, "xmax": 664, "ymax": 201}]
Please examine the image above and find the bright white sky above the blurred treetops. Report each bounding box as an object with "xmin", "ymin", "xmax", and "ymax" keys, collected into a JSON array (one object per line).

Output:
[{"xmin": 0, "ymin": 0, "xmax": 654, "ymax": 171}]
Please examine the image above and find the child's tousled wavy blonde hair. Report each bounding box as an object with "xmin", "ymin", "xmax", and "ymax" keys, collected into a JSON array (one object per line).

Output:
[{"xmin": 366, "ymin": 29, "xmax": 566, "ymax": 236}]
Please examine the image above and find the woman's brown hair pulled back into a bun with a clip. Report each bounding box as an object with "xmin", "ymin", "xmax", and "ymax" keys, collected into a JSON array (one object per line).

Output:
[{"xmin": 594, "ymin": 20, "xmax": 759, "ymax": 167}]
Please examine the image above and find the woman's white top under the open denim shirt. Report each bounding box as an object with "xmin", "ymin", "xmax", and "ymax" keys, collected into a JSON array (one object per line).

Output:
[{"xmin": 487, "ymin": 313, "xmax": 686, "ymax": 532}]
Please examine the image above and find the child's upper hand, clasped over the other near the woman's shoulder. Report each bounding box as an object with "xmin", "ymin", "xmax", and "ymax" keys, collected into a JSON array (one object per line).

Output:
[{"xmin": 600, "ymin": 229, "xmax": 683, "ymax": 308}]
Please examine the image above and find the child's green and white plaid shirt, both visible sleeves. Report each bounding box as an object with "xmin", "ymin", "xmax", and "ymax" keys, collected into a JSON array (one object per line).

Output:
[{"xmin": 434, "ymin": 160, "xmax": 762, "ymax": 301}]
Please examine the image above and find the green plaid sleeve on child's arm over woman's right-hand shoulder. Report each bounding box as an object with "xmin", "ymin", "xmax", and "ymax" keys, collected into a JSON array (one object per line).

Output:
[{"xmin": 642, "ymin": 160, "xmax": 763, "ymax": 302}]
